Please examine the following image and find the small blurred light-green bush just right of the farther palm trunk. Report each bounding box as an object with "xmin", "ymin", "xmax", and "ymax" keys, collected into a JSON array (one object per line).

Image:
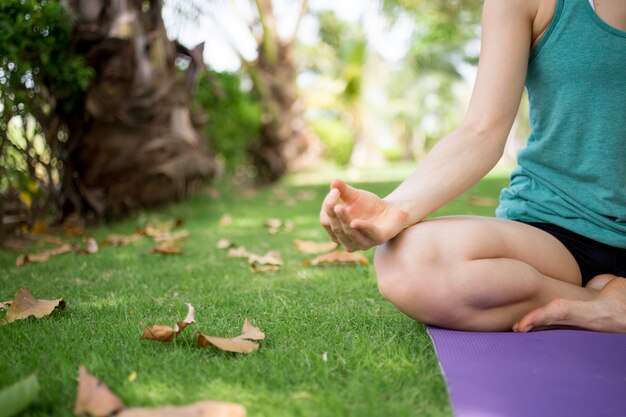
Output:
[{"xmin": 309, "ymin": 117, "xmax": 355, "ymax": 166}]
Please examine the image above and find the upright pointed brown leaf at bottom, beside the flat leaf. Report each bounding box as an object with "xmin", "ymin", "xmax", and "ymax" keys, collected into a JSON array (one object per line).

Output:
[{"xmin": 74, "ymin": 365, "xmax": 125, "ymax": 417}]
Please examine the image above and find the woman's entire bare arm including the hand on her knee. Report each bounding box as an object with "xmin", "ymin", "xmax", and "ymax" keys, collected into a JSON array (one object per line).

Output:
[{"xmin": 320, "ymin": 0, "xmax": 540, "ymax": 250}]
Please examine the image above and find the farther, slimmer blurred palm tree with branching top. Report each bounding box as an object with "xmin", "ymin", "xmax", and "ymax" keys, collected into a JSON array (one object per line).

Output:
[{"xmin": 177, "ymin": 0, "xmax": 321, "ymax": 183}]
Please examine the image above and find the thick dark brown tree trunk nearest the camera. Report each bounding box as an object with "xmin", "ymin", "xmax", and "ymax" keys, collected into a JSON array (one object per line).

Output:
[{"xmin": 63, "ymin": 0, "xmax": 215, "ymax": 217}]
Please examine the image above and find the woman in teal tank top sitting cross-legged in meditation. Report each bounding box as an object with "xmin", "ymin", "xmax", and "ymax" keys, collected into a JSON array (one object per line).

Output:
[{"xmin": 320, "ymin": 0, "xmax": 626, "ymax": 333}]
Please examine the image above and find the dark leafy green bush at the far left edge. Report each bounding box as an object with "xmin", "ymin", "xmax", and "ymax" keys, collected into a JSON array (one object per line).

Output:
[{"xmin": 0, "ymin": 0, "xmax": 93, "ymax": 220}]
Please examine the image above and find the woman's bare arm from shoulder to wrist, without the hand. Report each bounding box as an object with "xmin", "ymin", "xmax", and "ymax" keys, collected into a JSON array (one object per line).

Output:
[{"xmin": 385, "ymin": 0, "xmax": 534, "ymax": 224}]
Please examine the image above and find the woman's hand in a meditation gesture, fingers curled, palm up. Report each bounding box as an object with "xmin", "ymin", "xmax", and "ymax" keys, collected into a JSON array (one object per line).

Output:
[{"xmin": 320, "ymin": 180, "xmax": 410, "ymax": 252}]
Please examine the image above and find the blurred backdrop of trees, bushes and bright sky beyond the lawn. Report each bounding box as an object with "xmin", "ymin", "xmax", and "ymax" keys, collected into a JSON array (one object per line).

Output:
[{"xmin": 0, "ymin": 0, "xmax": 528, "ymax": 231}]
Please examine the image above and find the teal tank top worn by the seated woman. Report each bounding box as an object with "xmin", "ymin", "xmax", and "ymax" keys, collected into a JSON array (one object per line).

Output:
[{"xmin": 496, "ymin": 0, "xmax": 626, "ymax": 248}]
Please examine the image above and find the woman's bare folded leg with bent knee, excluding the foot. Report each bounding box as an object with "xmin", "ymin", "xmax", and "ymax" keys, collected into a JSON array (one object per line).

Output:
[{"xmin": 375, "ymin": 217, "xmax": 598, "ymax": 331}]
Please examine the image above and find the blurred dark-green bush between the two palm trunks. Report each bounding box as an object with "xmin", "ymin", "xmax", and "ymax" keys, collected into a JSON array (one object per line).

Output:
[{"xmin": 195, "ymin": 71, "xmax": 263, "ymax": 173}]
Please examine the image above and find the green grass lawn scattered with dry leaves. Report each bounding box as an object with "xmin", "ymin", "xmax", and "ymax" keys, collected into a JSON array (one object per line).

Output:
[{"xmin": 0, "ymin": 162, "xmax": 506, "ymax": 417}]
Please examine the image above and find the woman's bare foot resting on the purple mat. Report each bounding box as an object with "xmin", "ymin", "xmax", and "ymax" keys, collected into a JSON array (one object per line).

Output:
[{"xmin": 513, "ymin": 277, "xmax": 626, "ymax": 333}]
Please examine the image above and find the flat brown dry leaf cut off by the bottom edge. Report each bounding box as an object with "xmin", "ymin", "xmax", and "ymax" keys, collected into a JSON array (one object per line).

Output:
[{"xmin": 116, "ymin": 401, "xmax": 246, "ymax": 417}]
